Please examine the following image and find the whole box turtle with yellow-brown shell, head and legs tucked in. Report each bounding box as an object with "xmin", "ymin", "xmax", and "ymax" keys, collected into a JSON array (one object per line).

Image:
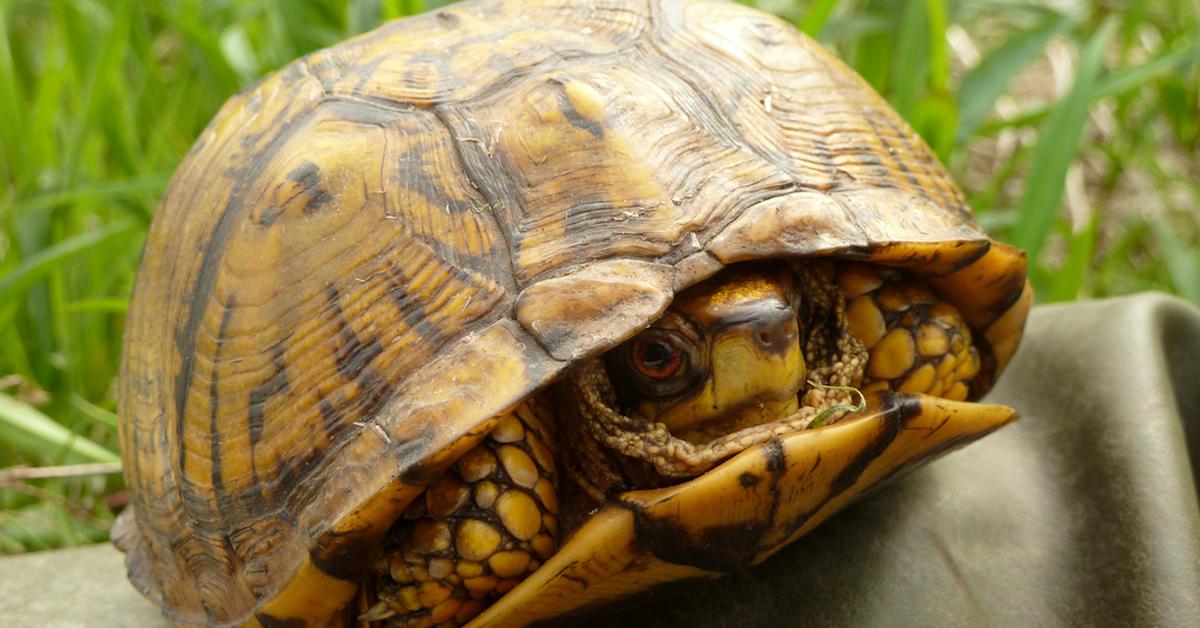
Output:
[{"xmin": 114, "ymin": 0, "xmax": 1031, "ymax": 626}]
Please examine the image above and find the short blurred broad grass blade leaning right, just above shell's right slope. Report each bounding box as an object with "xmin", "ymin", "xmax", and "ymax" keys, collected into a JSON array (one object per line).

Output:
[{"xmin": 955, "ymin": 13, "xmax": 1072, "ymax": 143}]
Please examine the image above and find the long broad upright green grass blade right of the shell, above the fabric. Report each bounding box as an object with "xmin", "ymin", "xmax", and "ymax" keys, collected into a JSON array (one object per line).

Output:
[{"xmin": 1013, "ymin": 17, "xmax": 1118, "ymax": 268}]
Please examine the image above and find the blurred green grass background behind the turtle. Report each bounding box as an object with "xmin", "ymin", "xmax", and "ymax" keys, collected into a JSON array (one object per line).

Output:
[{"xmin": 0, "ymin": 0, "xmax": 1200, "ymax": 552}]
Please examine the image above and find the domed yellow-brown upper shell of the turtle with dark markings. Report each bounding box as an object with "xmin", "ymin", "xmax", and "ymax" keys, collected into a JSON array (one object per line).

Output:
[{"xmin": 114, "ymin": 0, "xmax": 1030, "ymax": 624}]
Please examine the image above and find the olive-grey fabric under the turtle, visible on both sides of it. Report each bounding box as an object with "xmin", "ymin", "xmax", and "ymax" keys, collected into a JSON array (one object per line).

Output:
[{"xmin": 0, "ymin": 294, "xmax": 1200, "ymax": 627}]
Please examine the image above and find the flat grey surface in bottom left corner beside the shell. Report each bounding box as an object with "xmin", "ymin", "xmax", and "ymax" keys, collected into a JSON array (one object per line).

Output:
[{"xmin": 0, "ymin": 544, "xmax": 169, "ymax": 628}]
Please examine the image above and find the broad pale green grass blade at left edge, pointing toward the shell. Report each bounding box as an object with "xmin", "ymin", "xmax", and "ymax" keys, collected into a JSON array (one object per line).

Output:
[{"xmin": 0, "ymin": 393, "xmax": 120, "ymax": 462}]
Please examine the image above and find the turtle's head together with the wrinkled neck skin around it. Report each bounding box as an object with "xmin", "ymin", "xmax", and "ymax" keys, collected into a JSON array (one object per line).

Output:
[{"xmin": 560, "ymin": 259, "xmax": 866, "ymax": 498}]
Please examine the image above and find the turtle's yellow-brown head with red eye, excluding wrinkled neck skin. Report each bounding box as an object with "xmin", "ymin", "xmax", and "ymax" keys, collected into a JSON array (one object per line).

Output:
[{"xmin": 607, "ymin": 264, "xmax": 806, "ymax": 442}]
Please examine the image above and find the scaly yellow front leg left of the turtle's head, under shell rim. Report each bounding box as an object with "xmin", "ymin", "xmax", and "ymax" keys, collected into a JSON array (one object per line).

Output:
[{"xmin": 360, "ymin": 396, "xmax": 558, "ymax": 627}]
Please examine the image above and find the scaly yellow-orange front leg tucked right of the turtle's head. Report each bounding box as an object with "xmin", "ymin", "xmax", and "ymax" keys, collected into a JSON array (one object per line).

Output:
[{"xmin": 838, "ymin": 263, "xmax": 980, "ymax": 401}]
